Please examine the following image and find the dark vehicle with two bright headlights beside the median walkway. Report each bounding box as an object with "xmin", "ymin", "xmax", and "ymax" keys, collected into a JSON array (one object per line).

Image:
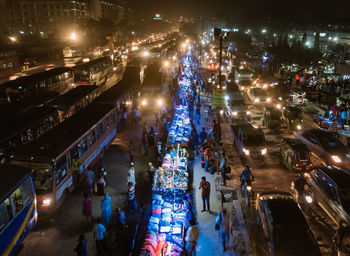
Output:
[{"xmin": 231, "ymin": 123, "xmax": 267, "ymax": 165}]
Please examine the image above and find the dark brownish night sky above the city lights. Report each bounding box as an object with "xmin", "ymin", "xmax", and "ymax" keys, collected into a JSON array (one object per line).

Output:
[{"xmin": 134, "ymin": 0, "xmax": 350, "ymax": 22}]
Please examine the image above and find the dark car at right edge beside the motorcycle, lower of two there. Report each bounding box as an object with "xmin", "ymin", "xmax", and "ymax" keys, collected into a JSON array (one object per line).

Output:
[{"xmin": 298, "ymin": 166, "xmax": 350, "ymax": 227}]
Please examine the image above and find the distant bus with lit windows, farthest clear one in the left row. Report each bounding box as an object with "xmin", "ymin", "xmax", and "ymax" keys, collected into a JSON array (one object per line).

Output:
[{"xmin": 73, "ymin": 56, "xmax": 113, "ymax": 85}]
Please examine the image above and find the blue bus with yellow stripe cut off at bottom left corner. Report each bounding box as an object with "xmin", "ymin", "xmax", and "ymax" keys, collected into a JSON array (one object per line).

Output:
[{"xmin": 0, "ymin": 165, "xmax": 38, "ymax": 255}]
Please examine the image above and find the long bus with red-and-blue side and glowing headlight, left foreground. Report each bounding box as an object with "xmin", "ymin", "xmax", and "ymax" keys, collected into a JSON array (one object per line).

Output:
[{"xmin": 10, "ymin": 102, "xmax": 116, "ymax": 214}]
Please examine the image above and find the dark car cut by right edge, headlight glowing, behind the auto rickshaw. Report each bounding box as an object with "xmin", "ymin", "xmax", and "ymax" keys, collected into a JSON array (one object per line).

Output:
[{"xmin": 296, "ymin": 128, "xmax": 350, "ymax": 172}]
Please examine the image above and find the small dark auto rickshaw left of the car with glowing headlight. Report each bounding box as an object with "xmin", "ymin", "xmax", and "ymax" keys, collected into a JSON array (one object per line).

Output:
[{"xmin": 281, "ymin": 138, "xmax": 312, "ymax": 172}]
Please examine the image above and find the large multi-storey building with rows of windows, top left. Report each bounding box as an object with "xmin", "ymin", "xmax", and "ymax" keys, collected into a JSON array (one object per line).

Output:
[{"xmin": 1, "ymin": 0, "xmax": 131, "ymax": 37}]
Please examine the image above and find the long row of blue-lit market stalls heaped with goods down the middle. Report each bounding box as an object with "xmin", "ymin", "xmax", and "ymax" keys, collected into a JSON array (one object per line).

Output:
[{"xmin": 141, "ymin": 49, "xmax": 198, "ymax": 256}]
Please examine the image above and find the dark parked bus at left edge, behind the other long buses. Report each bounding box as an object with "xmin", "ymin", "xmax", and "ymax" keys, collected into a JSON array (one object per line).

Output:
[{"xmin": 0, "ymin": 67, "xmax": 74, "ymax": 103}]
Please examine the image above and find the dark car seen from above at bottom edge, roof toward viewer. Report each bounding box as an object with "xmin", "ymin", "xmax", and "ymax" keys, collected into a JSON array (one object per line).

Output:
[{"xmin": 256, "ymin": 191, "xmax": 321, "ymax": 256}]
